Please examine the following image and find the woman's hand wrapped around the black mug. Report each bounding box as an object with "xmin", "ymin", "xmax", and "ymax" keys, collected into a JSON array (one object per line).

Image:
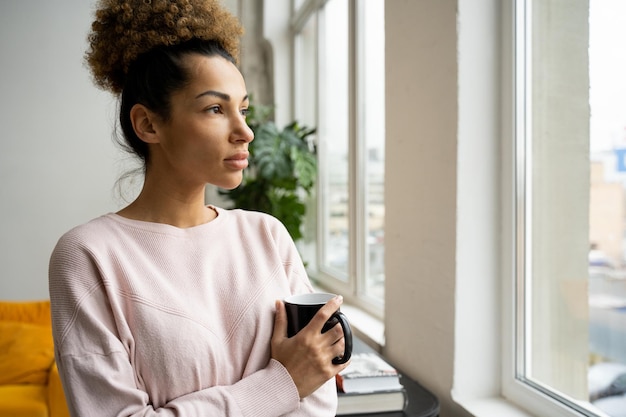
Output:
[{"xmin": 271, "ymin": 296, "xmax": 349, "ymax": 398}]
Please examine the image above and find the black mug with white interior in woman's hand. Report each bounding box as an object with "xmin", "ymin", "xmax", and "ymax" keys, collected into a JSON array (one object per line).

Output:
[{"xmin": 285, "ymin": 293, "xmax": 352, "ymax": 365}]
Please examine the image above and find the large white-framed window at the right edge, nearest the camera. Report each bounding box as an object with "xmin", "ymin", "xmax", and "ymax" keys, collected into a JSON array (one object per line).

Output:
[{"xmin": 505, "ymin": 0, "xmax": 626, "ymax": 417}]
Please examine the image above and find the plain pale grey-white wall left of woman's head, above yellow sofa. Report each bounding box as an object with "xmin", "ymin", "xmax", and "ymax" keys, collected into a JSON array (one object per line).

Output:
[{"xmin": 0, "ymin": 0, "xmax": 120, "ymax": 300}]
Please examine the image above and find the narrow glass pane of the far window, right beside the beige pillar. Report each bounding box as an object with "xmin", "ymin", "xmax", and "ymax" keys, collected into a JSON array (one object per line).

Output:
[{"xmin": 359, "ymin": 0, "xmax": 385, "ymax": 301}]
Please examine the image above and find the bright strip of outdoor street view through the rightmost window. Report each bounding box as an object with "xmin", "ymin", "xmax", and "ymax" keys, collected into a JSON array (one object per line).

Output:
[{"xmin": 588, "ymin": 0, "xmax": 626, "ymax": 416}]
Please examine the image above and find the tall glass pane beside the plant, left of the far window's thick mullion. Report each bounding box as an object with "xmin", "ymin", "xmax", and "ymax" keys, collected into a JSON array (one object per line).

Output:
[{"xmin": 319, "ymin": 0, "xmax": 350, "ymax": 281}]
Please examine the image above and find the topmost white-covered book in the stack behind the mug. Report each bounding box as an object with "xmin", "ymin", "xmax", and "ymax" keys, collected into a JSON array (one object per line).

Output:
[{"xmin": 336, "ymin": 352, "xmax": 402, "ymax": 394}]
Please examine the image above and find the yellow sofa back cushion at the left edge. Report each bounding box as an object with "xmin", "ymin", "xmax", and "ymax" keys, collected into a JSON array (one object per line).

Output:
[{"xmin": 0, "ymin": 321, "xmax": 54, "ymax": 385}]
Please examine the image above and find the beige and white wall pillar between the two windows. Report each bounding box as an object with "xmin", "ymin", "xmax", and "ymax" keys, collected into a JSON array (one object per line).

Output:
[{"xmin": 384, "ymin": 0, "xmax": 504, "ymax": 417}]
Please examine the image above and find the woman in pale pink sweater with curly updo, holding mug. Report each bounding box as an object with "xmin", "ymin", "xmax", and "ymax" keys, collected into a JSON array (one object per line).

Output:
[{"xmin": 49, "ymin": 0, "xmax": 346, "ymax": 417}]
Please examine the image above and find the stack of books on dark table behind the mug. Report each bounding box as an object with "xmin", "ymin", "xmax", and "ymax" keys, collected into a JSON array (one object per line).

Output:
[{"xmin": 336, "ymin": 352, "xmax": 407, "ymax": 416}]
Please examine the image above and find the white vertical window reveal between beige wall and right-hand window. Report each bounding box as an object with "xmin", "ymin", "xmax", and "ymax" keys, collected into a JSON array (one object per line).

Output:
[{"xmin": 453, "ymin": 0, "xmax": 498, "ymax": 400}]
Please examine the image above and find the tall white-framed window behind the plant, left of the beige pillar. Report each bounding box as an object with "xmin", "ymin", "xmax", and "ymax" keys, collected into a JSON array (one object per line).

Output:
[{"xmin": 292, "ymin": 0, "xmax": 385, "ymax": 316}]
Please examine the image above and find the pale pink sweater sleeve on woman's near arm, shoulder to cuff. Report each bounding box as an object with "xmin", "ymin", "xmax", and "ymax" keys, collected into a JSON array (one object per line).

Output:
[{"xmin": 49, "ymin": 231, "xmax": 300, "ymax": 417}]
